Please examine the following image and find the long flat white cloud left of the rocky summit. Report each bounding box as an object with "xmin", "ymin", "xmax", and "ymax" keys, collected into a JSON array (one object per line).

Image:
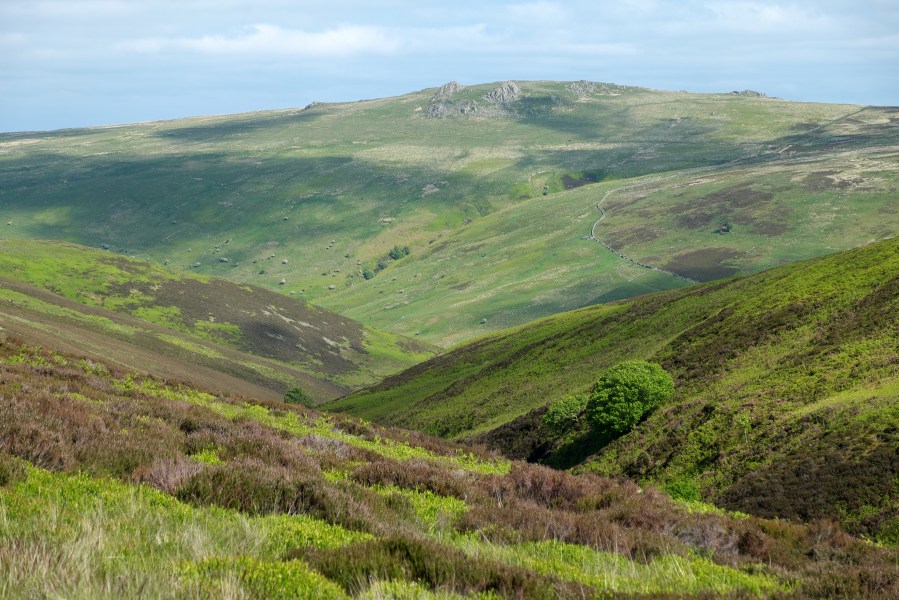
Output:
[{"xmin": 120, "ymin": 24, "xmax": 400, "ymax": 57}]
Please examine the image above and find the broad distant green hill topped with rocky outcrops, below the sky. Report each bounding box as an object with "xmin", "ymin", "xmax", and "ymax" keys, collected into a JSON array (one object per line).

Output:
[{"xmin": 0, "ymin": 82, "xmax": 899, "ymax": 345}]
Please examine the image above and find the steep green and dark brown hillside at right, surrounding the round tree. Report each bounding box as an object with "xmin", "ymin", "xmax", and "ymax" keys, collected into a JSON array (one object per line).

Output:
[{"xmin": 328, "ymin": 238, "xmax": 899, "ymax": 543}]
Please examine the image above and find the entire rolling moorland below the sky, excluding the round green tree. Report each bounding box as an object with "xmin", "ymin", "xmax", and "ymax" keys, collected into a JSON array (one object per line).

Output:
[{"xmin": 0, "ymin": 81, "xmax": 899, "ymax": 599}]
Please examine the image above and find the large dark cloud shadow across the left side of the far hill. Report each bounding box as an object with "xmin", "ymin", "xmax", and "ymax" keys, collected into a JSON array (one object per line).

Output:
[{"xmin": 0, "ymin": 148, "xmax": 478, "ymax": 251}]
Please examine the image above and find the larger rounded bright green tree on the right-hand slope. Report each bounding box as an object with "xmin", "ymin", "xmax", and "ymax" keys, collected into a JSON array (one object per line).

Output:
[{"xmin": 586, "ymin": 360, "xmax": 674, "ymax": 434}]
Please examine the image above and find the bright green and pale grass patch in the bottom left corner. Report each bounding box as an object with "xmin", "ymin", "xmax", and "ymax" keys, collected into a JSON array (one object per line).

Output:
[{"xmin": 0, "ymin": 467, "xmax": 365, "ymax": 598}]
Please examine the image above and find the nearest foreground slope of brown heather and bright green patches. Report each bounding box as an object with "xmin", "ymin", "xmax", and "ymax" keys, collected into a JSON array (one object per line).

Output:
[{"xmin": 0, "ymin": 338, "xmax": 899, "ymax": 599}]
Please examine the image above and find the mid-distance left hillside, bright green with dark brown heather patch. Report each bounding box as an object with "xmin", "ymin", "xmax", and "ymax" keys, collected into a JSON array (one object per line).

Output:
[{"xmin": 0, "ymin": 240, "xmax": 430, "ymax": 400}]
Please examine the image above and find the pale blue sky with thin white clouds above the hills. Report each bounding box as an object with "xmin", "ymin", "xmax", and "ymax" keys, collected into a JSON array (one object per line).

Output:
[{"xmin": 0, "ymin": 0, "xmax": 899, "ymax": 132}]
